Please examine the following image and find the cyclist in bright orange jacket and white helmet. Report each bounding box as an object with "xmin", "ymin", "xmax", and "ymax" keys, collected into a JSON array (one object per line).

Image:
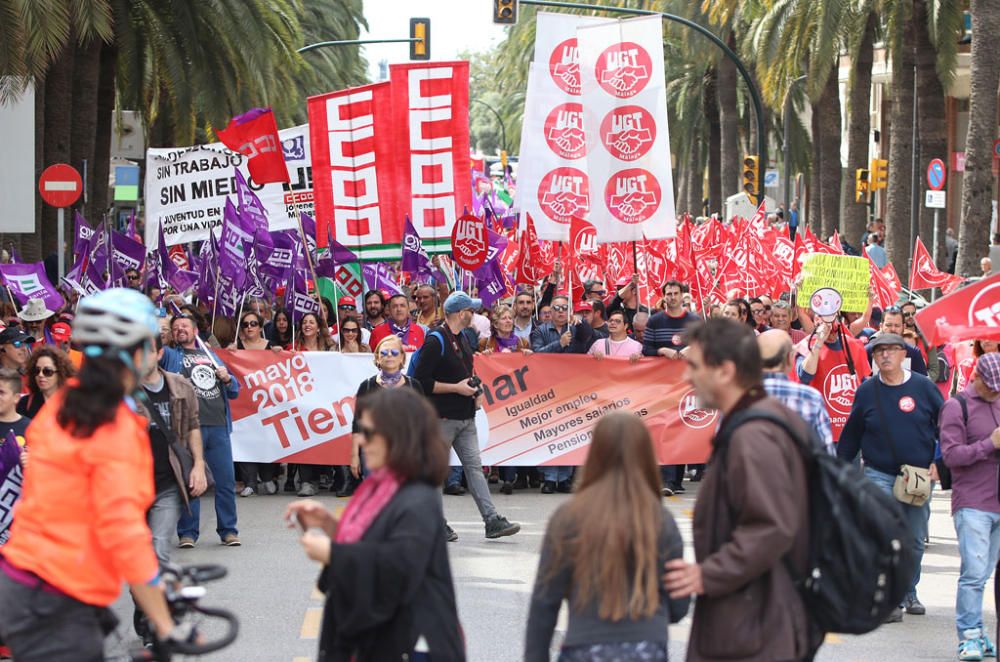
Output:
[{"xmin": 0, "ymin": 288, "xmax": 187, "ymax": 662}]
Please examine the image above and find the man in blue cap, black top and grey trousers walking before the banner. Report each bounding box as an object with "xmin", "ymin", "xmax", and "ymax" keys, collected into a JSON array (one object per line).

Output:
[{"xmin": 414, "ymin": 291, "xmax": 521, "ymax": 540}]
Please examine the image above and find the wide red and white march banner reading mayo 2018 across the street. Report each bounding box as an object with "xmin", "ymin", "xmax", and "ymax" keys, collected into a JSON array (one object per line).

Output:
[{"xmin": 218, "ymin": 350, "xmax": 718, "ymax": 466}]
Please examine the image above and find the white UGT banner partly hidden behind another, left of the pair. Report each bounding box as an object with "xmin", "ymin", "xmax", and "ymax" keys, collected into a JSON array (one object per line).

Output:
[{"xmin": 517, "ymin": 12, "xmax": 607, "ymax": 241}]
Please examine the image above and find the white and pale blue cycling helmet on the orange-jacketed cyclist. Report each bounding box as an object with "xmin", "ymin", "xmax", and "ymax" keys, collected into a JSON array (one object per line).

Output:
[{"xmin": 72, "ymin": 287, "xmax": 160, "ymax": 349}]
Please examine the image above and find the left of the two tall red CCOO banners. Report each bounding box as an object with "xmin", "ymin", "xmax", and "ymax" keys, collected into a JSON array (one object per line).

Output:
[{"xmin": 308, "ymin": 83, "xmax": 398, "ymax": 259}]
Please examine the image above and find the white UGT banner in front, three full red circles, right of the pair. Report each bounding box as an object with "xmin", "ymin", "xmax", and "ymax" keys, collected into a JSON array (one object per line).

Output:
[{"xmin": 576, "ymin": 16, "xmax": 677, "ymax": 243}]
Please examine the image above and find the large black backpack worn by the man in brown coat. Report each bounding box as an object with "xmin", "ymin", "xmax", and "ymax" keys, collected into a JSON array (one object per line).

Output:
[{"xmin": 715, "ymin": 409, "xmax": 915, "ymax": 634}]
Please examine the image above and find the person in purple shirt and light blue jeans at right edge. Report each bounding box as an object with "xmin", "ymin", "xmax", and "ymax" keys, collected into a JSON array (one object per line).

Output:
[{"xmin": 941, "ymin": 352, "xmax": 1000, "ymax": 660}]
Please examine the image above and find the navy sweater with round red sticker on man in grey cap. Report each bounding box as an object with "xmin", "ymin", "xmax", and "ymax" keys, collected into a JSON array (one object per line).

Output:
[{"xmin": 837, "ymin": 372, "xmax": 944, "ymax": 476}]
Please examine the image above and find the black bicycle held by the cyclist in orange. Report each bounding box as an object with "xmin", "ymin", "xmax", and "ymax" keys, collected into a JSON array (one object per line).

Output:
[{"xmin": 105, "ymin": 565, "xmax": 240, "ymax": 662}]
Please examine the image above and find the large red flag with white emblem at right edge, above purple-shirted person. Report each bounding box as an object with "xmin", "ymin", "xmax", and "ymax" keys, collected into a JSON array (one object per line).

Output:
[{"xmin": 916, "ymin": 274, "xmax": 1000, "ymax": 346}]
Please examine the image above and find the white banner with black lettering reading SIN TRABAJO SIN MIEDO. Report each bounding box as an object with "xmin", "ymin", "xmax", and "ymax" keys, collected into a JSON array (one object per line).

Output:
[{"xmin": 145, "ymin": 124, "xmax": 313, "ymax": 246}]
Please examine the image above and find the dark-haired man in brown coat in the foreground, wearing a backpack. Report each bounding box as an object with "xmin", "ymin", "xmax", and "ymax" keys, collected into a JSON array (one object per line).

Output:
[{"xmin": 664, "ymin": 318, "xmax": 823, "ymax": 662}]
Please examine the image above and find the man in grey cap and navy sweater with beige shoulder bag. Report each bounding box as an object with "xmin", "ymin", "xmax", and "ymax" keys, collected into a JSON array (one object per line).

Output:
[{"xmin": 837, "ymin": 333, "xmax": 944, "ymax": 623}]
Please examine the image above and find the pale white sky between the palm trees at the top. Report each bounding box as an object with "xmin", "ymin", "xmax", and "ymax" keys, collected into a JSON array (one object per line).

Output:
[{"xmin": 361, "ymin": 0, "xmax": 504, "ymax": 80}]
